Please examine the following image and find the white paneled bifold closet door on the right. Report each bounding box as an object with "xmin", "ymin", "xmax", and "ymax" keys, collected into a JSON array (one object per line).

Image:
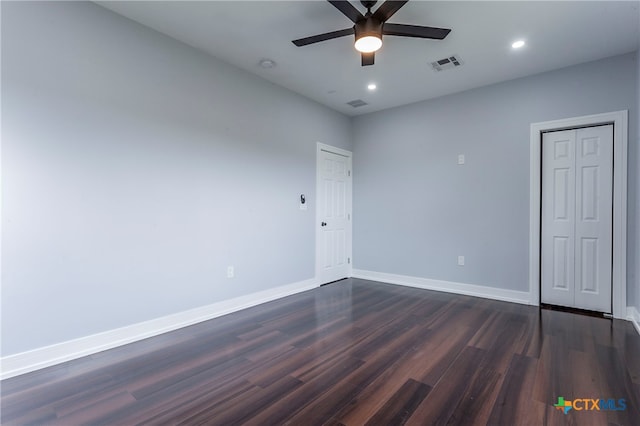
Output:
[{"xmin": 541, "ymin": 125, "xmax": 613, "ymax": 313}]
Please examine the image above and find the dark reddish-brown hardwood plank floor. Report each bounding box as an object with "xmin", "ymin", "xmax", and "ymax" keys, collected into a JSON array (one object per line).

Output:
[{"xmin": 1, "ymin": 279, "xmax": 640, "ymax": 426}]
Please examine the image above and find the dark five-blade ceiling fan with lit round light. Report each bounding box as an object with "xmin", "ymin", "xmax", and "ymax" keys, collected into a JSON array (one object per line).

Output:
[{"xmin": 292, "ymin": 0, "xmax": 451, "ymax": 67}]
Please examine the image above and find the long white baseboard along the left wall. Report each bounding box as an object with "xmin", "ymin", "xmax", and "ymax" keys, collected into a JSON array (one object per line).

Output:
[{"xmin": 0, "ymin": 278, "xmax": 318, "ymax": 380}]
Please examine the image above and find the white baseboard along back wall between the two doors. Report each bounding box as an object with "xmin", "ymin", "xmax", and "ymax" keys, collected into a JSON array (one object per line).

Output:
[{"xmin": 352, "ymin": 269, "xmax": 530, "ymax": 305}]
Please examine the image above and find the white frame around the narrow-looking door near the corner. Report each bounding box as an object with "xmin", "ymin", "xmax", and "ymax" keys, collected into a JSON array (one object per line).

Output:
[{"xmin": 313, "ymin": 142, "xmax": 353, "ymax": 284}]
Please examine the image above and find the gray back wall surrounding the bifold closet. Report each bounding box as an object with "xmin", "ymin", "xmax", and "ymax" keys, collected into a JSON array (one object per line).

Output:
[{"xmin": 353, "ymin": 54, "xmax": 638, "ymax": 291}]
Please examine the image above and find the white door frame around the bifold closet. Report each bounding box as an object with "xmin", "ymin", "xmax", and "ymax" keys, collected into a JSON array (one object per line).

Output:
[{"xmin": 529, "ymin": 110, "xmax": 628, "ymax": 319}]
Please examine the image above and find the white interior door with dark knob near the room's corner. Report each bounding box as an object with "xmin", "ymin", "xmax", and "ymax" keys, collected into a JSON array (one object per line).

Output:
[{"xmin": 316, "ymin": 146, "xmax": 351, "ymax": 283}]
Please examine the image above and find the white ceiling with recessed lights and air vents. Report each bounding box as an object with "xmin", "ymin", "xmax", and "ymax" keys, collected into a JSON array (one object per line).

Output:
[{"xmin": 97, "ymin": 0, "xmax": 640, "ymax": 115}]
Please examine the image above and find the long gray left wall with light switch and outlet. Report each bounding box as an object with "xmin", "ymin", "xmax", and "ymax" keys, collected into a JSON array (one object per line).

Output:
[{"xmin": 2, "ymin": 2, "xmax": 351, "ymax": 356}]
